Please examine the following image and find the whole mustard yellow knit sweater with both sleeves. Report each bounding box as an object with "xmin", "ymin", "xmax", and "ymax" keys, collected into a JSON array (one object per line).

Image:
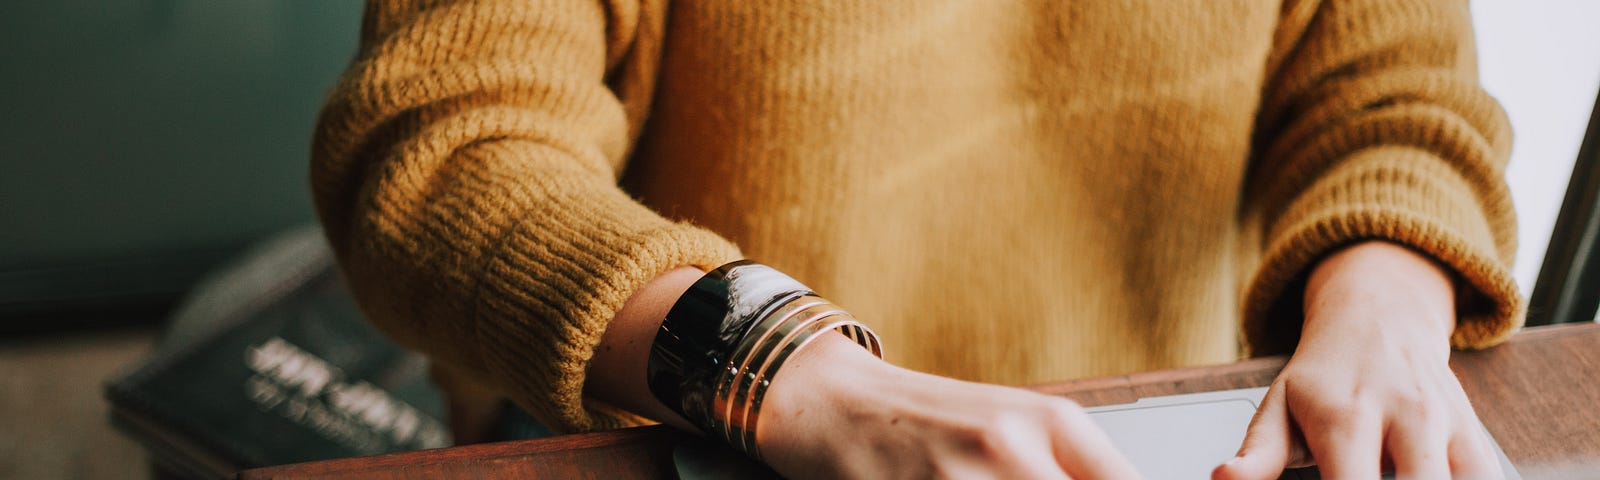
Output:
[{"xmin": 312, "ymin": 0, "xmax": 1523, "ymax": 430}]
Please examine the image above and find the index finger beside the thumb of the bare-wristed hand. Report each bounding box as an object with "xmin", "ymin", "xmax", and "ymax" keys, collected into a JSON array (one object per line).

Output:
[{"xmin": 1296, "ymin": 405, "xmax": 1382, "ymax": 480}]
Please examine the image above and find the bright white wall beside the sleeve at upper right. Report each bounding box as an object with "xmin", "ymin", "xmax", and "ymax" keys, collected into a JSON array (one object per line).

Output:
[{"xmin": 1472, "ymin": 0, "xmax": 1600, "ymax": 315}]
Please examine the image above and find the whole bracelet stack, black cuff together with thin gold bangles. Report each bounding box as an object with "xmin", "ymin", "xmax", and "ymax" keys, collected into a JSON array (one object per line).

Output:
[{"xmin": 648, "ymin": 261, "xmax": 883, "ymax": 458}]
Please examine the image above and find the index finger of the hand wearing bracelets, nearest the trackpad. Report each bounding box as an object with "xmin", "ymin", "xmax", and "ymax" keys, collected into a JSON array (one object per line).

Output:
[{"xmin": 1051, "ymin": 403, "xmax": 1141, "ymax": 478}]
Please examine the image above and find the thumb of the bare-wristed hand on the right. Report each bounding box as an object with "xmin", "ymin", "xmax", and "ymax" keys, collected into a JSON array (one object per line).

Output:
[{"xmin": 1211, "ymin": 382, "xmax": 1304, "ymax": 480}]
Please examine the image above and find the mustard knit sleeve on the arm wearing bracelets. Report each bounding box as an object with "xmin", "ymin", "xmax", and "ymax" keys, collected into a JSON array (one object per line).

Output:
[{"xmin": 312, "ymin": 0, "xmax": 739, "ymax": 432}]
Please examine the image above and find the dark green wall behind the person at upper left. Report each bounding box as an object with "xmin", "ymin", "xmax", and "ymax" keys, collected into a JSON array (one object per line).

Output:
[{"xmin": 0, "ymin": 0, "xmax": 362, "ymax": 324}]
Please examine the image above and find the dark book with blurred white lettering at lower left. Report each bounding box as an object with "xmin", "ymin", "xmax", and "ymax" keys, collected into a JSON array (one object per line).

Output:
[{"xmin": 106, "ymin": 229, "xmax": 450, "ymax": 478}]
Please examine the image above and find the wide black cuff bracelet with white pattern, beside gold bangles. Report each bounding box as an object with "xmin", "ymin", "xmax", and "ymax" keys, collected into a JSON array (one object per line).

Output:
[{"xmin": 646, "ymin": 261, "xmax": 811, "ymax": 432}]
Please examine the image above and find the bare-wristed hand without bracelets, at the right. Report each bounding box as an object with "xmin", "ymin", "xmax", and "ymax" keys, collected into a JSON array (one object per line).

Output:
[{"xmin": 1211, "ymin": 242, "xmax": 1502, "ymax": 480}]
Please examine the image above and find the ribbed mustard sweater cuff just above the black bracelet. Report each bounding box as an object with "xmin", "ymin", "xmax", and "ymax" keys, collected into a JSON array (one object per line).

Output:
[{"xmin": 464, "ymin": 195, "xmax": 741, "ymax": 432}]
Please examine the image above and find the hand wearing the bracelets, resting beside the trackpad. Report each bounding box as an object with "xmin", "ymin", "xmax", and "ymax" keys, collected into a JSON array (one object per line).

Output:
[{"xmin": 757, "ymin": 334, "xmax": 1139, "ymax": 478}]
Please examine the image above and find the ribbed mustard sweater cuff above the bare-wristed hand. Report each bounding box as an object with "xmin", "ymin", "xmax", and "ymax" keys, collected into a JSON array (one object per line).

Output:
[{"xmin": 1245, "ymin": 147, "xmax": 1525, "ymax": 355}]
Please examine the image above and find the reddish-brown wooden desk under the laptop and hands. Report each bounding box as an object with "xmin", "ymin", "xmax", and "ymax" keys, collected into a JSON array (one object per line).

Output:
[{"xmin": 240, "ymin": 323, "xmax": 1600, "ymax": 478}]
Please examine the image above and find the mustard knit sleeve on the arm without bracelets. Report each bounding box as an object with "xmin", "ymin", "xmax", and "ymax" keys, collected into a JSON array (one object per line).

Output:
[{"xmin": 1243, "ymin": 0, "xmax": 1523, "ymax": 354}]
